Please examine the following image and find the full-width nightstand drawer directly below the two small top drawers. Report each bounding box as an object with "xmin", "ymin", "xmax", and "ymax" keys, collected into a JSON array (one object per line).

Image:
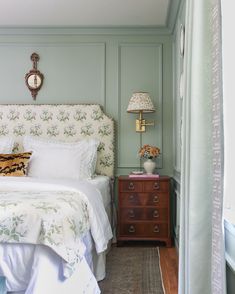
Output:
[{"xmin": 119, "ymin": 192, "xmax": 169, "ymax": 207}]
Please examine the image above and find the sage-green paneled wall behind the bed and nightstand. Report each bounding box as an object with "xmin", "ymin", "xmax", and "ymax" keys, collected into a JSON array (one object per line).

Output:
[{"xmin": 0, "ymin": 28, "xmax": 173, "ymax": 175}]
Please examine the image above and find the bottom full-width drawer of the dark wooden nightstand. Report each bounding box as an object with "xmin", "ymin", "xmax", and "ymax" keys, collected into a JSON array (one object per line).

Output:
[{"xmin": 120, "ymin": 222, "xmax": 168, "ymax": 238}]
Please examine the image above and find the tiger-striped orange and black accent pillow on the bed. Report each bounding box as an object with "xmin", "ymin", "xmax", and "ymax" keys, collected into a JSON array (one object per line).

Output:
[{"xmin": 0, "ymin": 152, "xmax": 32, "ymax": 177}]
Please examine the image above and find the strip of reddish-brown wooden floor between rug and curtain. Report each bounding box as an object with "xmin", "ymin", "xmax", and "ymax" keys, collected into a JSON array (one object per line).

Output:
[{"xmin": 159, "ymin": 247, "xmax": 178, "ymax": 294}]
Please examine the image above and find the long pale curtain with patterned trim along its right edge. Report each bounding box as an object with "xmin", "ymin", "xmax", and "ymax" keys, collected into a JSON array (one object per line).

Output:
[{"xmin": 179, "ymin": 0, "xmax": 225, "ymax": 294}]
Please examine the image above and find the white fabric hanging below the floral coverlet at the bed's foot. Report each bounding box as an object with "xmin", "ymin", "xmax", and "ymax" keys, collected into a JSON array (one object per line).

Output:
[{"xmin": 0, "ymin": 244, "xmax": 100, "ymax": 294}]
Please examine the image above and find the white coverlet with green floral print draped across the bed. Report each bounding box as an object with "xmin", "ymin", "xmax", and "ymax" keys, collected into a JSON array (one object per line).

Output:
[{"xmin": 0, "ymin": 191, "xmax": 90, "ymax": 277}]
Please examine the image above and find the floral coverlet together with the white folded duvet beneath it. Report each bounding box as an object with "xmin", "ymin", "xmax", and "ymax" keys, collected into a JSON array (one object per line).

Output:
[{"xmin": 0, "ymin": 178, "xmax": 112, "ymax": 277}]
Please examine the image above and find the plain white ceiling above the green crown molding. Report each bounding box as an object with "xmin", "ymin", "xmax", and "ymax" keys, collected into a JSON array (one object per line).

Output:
[{"xmin": 0, "ymin": 0, "xmax": 172, "ymax": 27}]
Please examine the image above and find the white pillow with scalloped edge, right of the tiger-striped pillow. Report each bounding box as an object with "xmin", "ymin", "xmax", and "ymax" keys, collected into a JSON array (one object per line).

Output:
[{"xmin": 23, "ymin": 136, "xmax": 99, "ymax": 179}]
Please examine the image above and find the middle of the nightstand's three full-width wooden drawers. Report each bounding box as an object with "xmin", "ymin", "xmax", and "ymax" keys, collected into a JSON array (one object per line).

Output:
[{"xmin": 120, "ymin": 207, "xmax": 168, "ymax": 222}]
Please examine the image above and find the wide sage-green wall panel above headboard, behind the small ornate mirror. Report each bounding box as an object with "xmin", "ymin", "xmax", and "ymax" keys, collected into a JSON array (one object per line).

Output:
[{"xmin": 0, "ymin": 43, "xmax": 105, "ymax": 105}]
